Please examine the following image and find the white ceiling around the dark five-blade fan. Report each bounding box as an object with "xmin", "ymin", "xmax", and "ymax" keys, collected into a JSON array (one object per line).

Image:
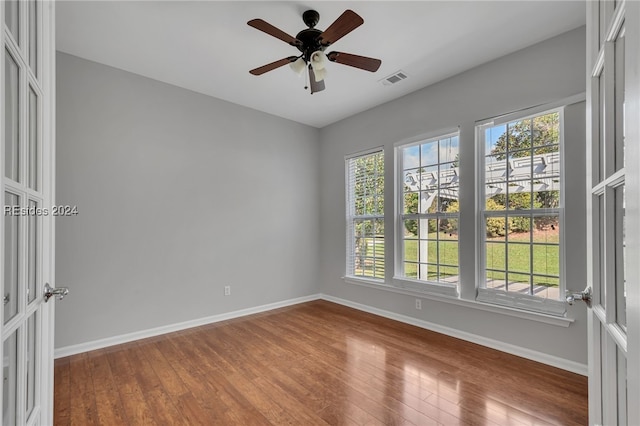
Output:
[{"xmin": 56, "ymin": 0, "xmax": 585, "ymax": 127}]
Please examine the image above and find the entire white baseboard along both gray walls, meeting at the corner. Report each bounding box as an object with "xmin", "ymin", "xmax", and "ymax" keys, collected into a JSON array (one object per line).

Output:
[{"xmin": 54, "ymin": 294, "xmax": 587, "ymax": 376}]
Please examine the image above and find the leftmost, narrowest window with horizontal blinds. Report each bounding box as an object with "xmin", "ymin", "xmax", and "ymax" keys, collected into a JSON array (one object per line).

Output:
[{"xmin": 346, "ymin": 149, "xmax": 385, "ymax": 281}]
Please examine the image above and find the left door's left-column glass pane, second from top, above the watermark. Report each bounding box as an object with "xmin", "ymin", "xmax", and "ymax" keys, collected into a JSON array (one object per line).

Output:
[{"xmin": 4, "ymin": 50, "xmax": 20, "ymax": 181}]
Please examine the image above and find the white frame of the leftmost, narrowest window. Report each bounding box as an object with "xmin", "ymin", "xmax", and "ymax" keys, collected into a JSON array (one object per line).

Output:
[{"xmin": 345, "ymin": 147, "xmax": 387, "ymax": 284}]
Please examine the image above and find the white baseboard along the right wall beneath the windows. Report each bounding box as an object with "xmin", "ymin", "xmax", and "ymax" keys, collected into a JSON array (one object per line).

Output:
[{"xmin": 320, "ymin": 294, "xmax": 588, "ymax": 376}]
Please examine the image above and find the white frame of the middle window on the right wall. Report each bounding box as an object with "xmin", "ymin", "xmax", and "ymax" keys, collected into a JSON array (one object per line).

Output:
[{"xmin": 393, "ymin": 128, "xmax": 460, "ymax": 297}]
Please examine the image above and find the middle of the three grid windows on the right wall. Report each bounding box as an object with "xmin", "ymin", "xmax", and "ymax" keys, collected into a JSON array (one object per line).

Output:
[{"xmin": 397, "ymin": 133, "xmax": 460, "ymax": 287}]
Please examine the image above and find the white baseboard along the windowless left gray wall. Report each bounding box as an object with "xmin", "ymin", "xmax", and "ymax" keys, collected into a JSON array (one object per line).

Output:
[{"xmin": 53, "ymin": 294, "xmax": 321, "ymax": 358}]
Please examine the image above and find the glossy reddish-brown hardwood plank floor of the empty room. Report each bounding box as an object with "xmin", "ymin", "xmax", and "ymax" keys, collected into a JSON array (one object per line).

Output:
[{"xmin": 55, "ymin": 301, "xmax": 588, "ymax": 425}]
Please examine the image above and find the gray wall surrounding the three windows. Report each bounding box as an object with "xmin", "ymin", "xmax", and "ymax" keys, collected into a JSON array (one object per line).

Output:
[{"xmin": 320, "ymin": 28, "xmax": 587, "ymax": 364}]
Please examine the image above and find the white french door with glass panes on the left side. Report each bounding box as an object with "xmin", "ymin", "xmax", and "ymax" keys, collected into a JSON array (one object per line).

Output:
[{"xmin": 0, "ymin": 0, "xmax": 55, "ymax": 425}]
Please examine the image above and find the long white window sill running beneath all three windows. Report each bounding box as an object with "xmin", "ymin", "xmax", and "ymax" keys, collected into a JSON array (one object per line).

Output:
[{"xmin": 343, "ymin": 277, "xmax": 575, "ymax": 327}]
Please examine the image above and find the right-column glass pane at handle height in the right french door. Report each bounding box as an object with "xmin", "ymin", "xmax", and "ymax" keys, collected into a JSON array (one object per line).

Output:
[{"xmin": 614, "ymin": 185, "xmax": 627, "ymax": 330}]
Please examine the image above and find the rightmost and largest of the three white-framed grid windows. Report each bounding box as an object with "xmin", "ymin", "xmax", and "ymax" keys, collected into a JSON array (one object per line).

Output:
[{"xmin": 478, "ymin": 110, "xmax": 564, "ymax": 313}]
